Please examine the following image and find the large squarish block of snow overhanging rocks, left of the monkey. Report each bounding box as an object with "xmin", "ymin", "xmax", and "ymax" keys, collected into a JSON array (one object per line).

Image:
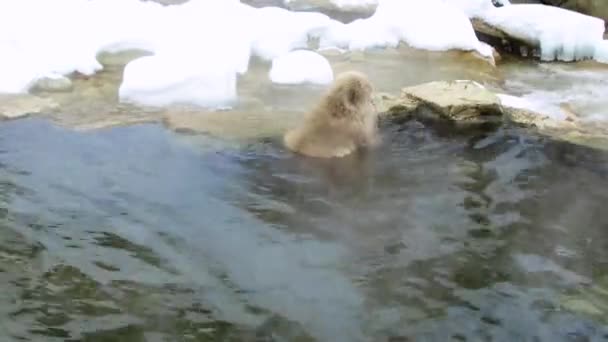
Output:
[{"xmin": 119, "ymin": 55, "xmax": 237, "ymax": 108}]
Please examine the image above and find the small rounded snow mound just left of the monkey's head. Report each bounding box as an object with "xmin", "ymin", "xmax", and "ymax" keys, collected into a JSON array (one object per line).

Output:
[{"xmin": 269, "ymin": 50, "xmax": 334, "ymax": 84}]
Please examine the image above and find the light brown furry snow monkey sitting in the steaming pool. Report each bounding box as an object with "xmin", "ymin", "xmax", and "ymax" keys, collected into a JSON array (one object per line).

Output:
[{"xmin": 284, "ymin": 71, "xmax": 379, "ymax": 158}]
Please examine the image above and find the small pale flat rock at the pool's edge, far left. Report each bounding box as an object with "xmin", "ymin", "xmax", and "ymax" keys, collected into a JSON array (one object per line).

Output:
[{"xmin": 0, "ymin": 94, "xmax": 59, "ymax": 119}]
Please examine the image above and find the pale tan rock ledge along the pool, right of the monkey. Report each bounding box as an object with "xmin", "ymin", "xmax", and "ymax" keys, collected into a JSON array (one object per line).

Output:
[{"xmin": 382, "ymin": 81, "xmax": 608, "ymax": 150}]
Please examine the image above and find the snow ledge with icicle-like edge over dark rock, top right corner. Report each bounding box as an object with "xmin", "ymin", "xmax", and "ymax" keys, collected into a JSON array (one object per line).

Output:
[{"xmin": 477, "ymin": 4, "xmax": 606, "ymax": 62}]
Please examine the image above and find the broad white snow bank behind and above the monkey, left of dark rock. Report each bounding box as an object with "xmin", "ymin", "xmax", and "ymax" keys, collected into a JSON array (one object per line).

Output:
[{"xmin": 320, "ymin": 0, "xmax": 487, "ymax": 54}]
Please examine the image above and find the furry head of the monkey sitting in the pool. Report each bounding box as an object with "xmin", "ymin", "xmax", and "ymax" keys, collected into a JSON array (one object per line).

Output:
[{"xmin": 325, "ymin": 71, "xmax": 375, "ymax": 119}]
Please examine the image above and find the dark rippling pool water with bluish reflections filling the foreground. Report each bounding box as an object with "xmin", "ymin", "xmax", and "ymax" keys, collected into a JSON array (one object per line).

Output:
[{"xmin": 0, "ymin": 119, "xmax": 608, "ymax": 341}]
